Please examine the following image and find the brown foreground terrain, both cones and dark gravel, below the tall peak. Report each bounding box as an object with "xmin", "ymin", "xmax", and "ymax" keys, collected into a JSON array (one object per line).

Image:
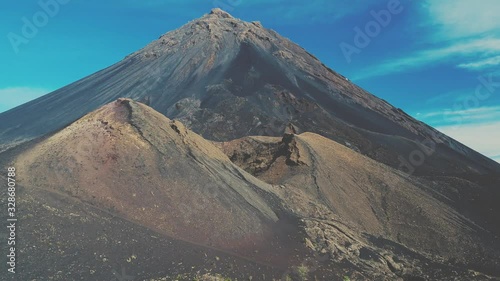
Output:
[{"xmin": 0, "ymin": 99, "xmax": 500, "ymax": 280}]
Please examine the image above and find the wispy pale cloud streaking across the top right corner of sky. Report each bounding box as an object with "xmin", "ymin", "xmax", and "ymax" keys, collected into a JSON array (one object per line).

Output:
[{"xmin": 352, "ymin": 0, "xmax": 500, "ymax": 81}]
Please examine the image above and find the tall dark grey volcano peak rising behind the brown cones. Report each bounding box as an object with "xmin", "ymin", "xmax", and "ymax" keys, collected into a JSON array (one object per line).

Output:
[{"xmin": 0, "ymin": 9, "xmax": 500, "ymax": 180}]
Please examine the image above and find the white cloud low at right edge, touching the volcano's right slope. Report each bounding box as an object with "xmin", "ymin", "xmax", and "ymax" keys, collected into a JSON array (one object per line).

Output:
[{"xmin": 436, "ymin": 121, "xmax": 500, "ymax": 162}]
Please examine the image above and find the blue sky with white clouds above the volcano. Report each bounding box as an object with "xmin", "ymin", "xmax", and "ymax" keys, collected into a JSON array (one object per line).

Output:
[{"xmin": 0, "ymin": 0, "xmax": 500, "ymax": 161}]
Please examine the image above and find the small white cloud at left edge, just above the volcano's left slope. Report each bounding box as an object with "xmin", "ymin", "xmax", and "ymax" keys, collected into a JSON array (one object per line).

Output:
[{"xmin": 0, "ymin": 87, "xmax": 50, "ymax": 112}]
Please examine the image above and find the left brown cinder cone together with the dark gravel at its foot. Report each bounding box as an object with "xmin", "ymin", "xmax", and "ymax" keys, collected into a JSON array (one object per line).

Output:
[{"xmin": 1, "ymin": 99, "xmax": 308, "ymax": 280}]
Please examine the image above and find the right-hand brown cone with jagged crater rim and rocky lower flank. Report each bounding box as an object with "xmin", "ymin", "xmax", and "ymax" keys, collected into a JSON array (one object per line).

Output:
[{"xmin": 217, "ymin": 133, "xmax": 500, "ymax": 280}]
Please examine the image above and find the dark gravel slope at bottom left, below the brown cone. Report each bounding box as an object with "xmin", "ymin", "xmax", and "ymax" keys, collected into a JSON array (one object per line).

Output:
[{"xmin": 0, "ymin": 178, "xmax": 285, "ymax": 281}]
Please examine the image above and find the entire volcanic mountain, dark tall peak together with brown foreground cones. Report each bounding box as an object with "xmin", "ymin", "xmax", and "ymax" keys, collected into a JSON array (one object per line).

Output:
[{"xmin": 0, "ymin": 9, "xmax": 500, "ymax": 280}]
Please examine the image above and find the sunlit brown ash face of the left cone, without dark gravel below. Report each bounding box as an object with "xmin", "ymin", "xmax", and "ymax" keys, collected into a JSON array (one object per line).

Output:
[{"xmin": 15, "ymin": 99, "xmax": 304, "ymax": 260}]
